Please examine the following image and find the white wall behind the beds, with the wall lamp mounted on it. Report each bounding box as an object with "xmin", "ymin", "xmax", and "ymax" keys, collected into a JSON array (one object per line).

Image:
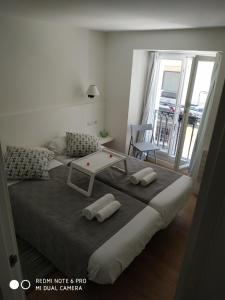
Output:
[{"xmin": 0, "ymin": 17, "xmax": 105, "ymax": 144}]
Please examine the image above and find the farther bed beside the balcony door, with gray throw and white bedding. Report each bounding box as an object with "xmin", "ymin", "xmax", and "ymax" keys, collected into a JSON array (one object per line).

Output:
[{"xmin": 57, "ymin": 155, "xmax": 192, "ymax": 228}]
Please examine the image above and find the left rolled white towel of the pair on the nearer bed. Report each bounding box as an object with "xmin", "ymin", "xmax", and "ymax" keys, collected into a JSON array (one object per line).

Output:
[{"xmin": 82, "ymin": 194, "xmax": 115, "ymax": 220}]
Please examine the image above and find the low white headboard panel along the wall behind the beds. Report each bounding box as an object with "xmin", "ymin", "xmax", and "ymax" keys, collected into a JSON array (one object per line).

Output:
[{"xmin": 0, "ymin": 101, "xmax": 104, "ymax": 148}]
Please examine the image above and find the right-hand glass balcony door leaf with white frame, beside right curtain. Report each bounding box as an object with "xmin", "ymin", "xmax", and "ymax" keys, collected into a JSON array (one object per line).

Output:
[{"xmin": 175, "ymin": 56, "xmax": 215, "ymax": 170}]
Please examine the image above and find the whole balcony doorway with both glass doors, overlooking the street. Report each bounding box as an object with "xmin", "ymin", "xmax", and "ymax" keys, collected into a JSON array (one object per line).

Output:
[{"xmin": 150, "ymin": 53, "xmax": 215, "ymax": 170}]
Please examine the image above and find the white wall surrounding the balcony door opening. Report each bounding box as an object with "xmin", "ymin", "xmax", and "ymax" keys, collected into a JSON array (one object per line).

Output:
[{"xmin": 106, "ymin": 28, "xmax": 225, "ymax": 151}]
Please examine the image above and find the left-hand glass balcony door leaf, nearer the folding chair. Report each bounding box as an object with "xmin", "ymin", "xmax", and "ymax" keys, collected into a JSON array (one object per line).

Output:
[{"xmin": 152, "ymin": 54, "xmax": 191, "ymax": 168}]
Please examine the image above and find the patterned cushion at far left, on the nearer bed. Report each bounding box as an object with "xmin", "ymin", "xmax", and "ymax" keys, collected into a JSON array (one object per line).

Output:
[{"xmin": 5, "ymin": 146, "xmax": 54, "ymax": 180}]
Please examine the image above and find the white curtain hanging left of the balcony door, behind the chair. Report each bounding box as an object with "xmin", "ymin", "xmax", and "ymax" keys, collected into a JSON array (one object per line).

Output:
[{"xmin": 138, "ymin": 52, "xmax": 159, "ymax": 142}]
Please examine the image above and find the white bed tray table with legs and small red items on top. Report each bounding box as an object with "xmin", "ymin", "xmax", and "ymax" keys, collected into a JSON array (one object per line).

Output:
[{"xmin": 67, "ymin": 148, "xmax": 127, "ymax": 197}]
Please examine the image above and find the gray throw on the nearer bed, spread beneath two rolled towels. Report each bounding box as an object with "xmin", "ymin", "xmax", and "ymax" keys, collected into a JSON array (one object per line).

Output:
[{"xmin": 9, "ymin": 166, "xmax": 145, "ymax": 278}]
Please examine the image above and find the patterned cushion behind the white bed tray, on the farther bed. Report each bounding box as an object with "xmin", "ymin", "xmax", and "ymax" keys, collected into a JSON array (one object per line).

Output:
[{"xmin": 66, "ymin": 132, "xmax": 99, "ymax": 157}]
